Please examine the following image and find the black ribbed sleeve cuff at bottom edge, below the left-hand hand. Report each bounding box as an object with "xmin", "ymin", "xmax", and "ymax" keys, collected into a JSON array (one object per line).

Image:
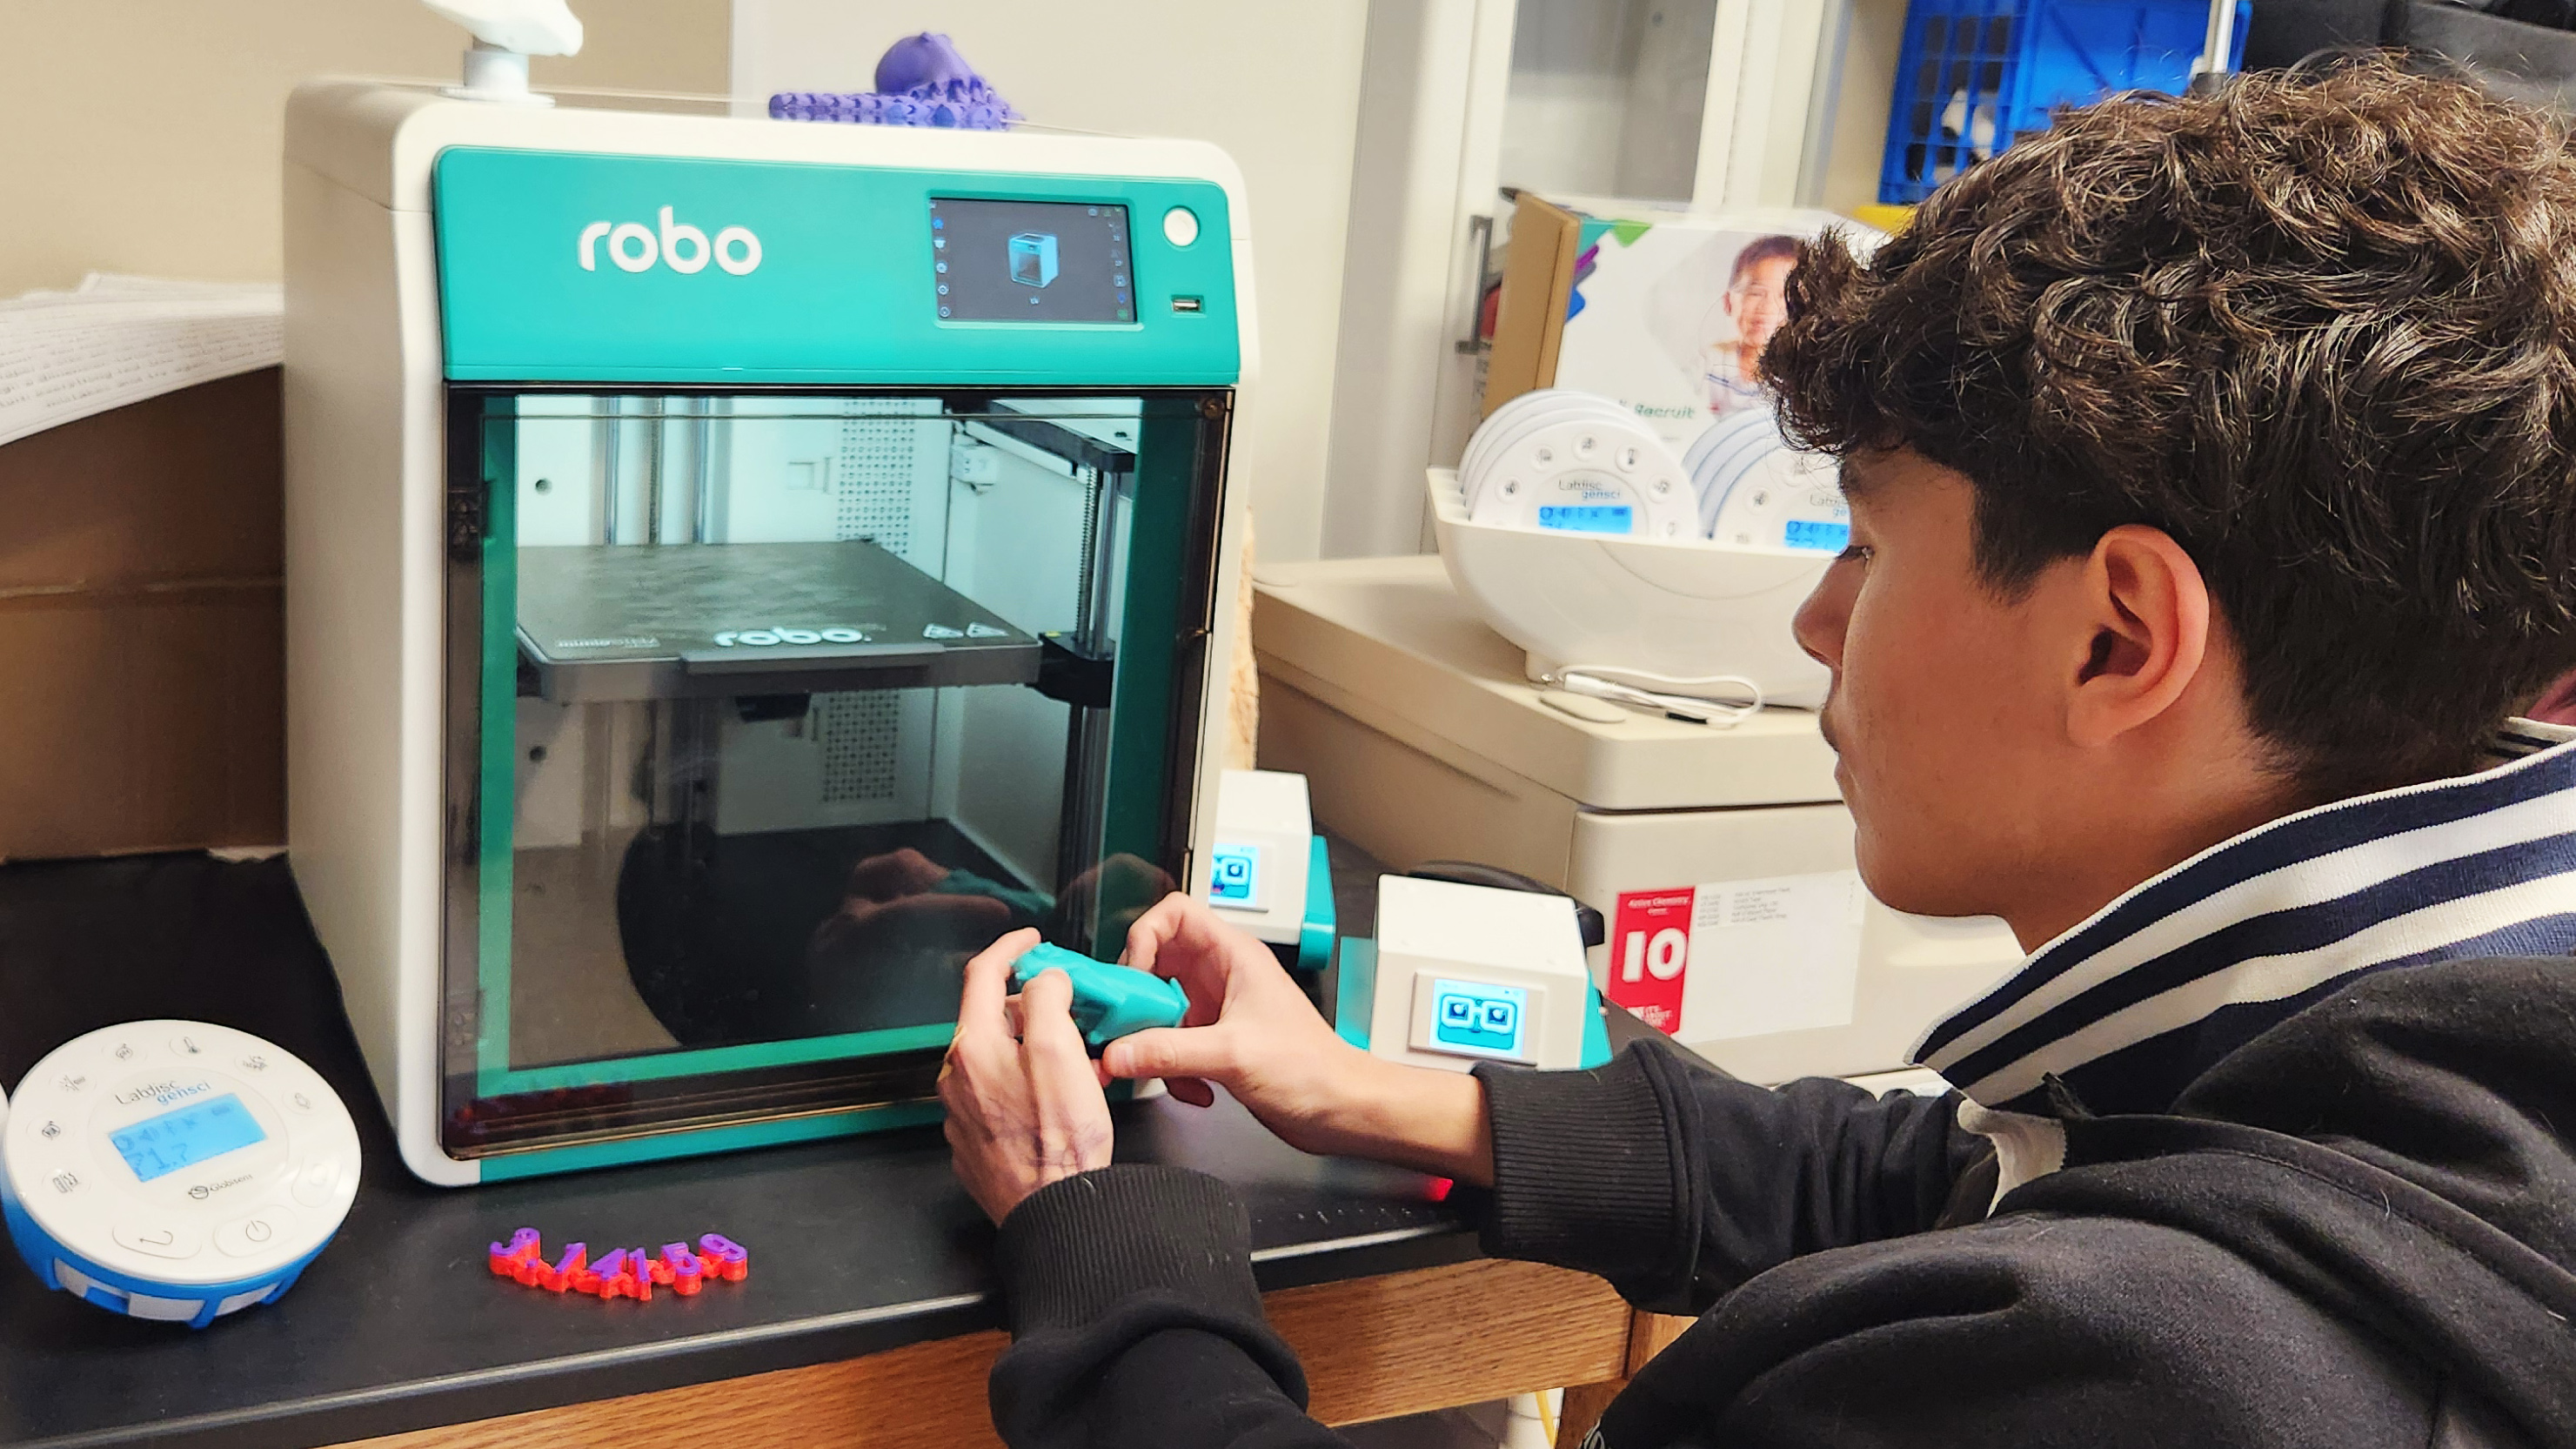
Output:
[{"xmin": 989, "ymin": 1163, "xmax": 1345, "ymax": 1449}]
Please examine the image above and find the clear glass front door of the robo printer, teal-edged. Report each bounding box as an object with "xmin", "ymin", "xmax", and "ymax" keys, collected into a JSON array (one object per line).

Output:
[{"xmin": 443, "ymin": 392, "xmax": 1223, "ymax": 1155}]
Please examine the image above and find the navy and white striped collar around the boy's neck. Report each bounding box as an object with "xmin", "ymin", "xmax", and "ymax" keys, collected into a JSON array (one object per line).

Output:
[{"xmin": 1914, "ymin": 720, "xmax": 2576, "ymax": 1114}]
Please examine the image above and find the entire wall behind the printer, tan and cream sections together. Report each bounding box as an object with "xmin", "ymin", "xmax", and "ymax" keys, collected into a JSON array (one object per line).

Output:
[{"xmin": 0, "ymin": 0, "xmax": 1368, "ymax": 560}]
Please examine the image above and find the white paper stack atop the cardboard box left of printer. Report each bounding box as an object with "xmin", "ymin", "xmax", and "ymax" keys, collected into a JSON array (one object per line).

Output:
[{"xmin": 0, "ymin": 273, "xmax": 286, "ymax": 444}]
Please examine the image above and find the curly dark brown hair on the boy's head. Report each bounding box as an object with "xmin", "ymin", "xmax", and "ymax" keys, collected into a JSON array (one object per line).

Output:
[{"xmin": 1762, "ymin": 57, "xmax": 2576, "ymax": 799}]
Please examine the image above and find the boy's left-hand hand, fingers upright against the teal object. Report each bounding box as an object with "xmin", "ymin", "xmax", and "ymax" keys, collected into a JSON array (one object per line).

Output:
[{"xmin": 940, "ymin": 931, "xmax": 1110, "ymax": 1222}]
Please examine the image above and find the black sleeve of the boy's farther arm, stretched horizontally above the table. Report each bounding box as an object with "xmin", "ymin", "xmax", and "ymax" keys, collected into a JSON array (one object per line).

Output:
[{"xmin": 1476, "ymin": 1042, "xmax": 1981, "ymax": 1312}]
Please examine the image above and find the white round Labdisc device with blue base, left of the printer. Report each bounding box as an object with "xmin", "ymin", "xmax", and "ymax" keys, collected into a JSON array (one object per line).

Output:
[{"xmin": 0, "ymin": 1021, "xmax": 358, "ymax": 1328}]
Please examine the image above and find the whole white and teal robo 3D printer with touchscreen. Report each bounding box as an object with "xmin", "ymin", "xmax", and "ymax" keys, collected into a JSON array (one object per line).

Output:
[{"xmin": 286, "ymin": 83, "xmax": 1252, "ymax": 1184}]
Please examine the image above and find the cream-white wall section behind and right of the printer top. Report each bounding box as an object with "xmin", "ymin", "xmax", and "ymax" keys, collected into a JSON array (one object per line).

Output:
[{"xmin": 734, "ymin": 0, "xmax": 1368, "ymax": 560}]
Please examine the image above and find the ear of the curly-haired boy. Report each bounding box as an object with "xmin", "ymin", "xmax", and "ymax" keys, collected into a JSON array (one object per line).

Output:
[{"xmin": 2066, "ymin": 523, "xmax": 2211, "ymax": 745}]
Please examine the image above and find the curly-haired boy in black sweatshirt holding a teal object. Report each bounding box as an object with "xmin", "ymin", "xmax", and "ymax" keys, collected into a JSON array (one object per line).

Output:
[{"xmin": 946, "ymin": 62, "xmax": 2576, "ymax": 1449}]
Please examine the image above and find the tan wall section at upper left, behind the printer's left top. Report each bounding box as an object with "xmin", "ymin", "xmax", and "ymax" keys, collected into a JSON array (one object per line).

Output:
[{"xmin": 0, "ymin": 0, "xmax": 732, "ymax": 297}]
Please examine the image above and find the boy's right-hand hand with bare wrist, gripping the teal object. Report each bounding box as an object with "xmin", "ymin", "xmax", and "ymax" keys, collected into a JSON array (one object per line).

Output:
[{"xmin": 1100, "ymin": 892, "xmax": 1494, "ymax": 1184}]
